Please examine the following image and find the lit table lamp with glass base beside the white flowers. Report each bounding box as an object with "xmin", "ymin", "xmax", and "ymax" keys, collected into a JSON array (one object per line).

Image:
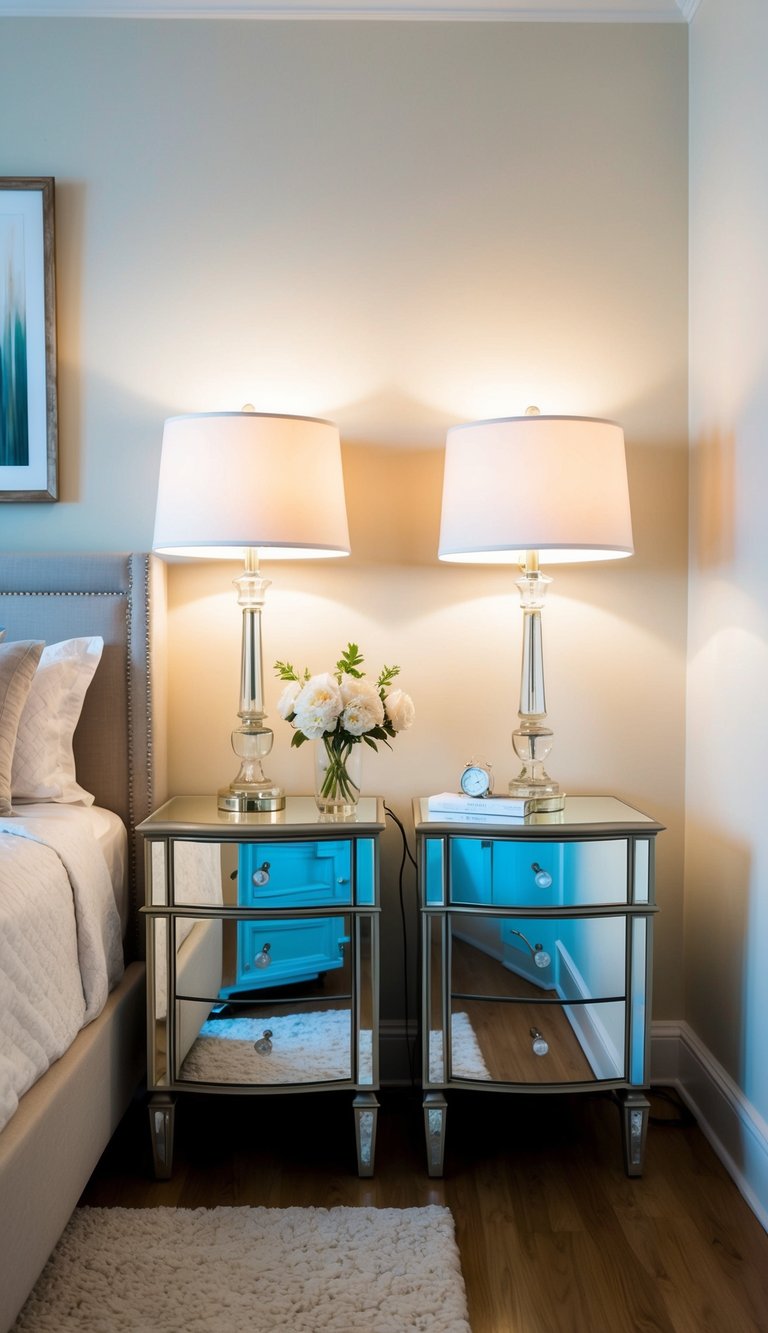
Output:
[{"xmin": 152, "ymin": 408, "xmax": 349, "ymax": 813}]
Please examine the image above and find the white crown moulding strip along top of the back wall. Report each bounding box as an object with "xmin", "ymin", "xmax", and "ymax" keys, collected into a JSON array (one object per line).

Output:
[{"xmin": 0, "ymin": 0, "xmax": 700, "ymax": 23}]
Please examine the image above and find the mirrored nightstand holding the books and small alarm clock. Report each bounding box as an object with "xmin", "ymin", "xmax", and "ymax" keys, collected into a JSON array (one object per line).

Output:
[{"xmin": 413, "ymin": 796, "xmax": 663, "ymax": 1176}]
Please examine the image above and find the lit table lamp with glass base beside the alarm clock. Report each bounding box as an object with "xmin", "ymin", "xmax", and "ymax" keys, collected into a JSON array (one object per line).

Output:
[{"xmin": 439, "ymin": 408, "xmax": 633, "ymax": 812}]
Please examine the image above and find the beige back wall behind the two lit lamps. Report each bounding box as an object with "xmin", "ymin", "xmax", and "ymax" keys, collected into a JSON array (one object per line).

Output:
[{"xmin": 0, "ymin": 20, "xmax": 687, "ymax": 1017}]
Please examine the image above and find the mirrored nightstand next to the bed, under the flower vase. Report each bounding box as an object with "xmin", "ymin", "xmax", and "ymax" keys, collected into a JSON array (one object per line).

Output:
[{"xmin": 140, "ymin": 797, "xmax": 384, "ymax": 1177}]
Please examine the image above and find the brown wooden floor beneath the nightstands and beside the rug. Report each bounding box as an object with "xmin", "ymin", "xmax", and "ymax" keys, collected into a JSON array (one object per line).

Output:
[{"xmin": 81, "ymin": 1092, "xmax": 768, "ymax": 1333}]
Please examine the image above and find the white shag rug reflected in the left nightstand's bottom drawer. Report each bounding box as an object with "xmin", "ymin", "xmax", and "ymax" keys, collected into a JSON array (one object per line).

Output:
[{"xmin": 180, "ymin": 1009, "xmax": 372, "ymax": 1084}]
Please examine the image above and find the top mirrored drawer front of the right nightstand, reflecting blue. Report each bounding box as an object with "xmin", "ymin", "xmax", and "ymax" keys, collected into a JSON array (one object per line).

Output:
[{"xmin": 448, "ymin": 837, "xmax": 629, "ymax": 908}]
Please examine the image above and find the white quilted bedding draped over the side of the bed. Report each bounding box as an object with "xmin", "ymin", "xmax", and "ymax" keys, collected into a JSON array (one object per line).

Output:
[{"xmin": 0, "ymin": 805, "xmax": 124, "ymax": 1129}]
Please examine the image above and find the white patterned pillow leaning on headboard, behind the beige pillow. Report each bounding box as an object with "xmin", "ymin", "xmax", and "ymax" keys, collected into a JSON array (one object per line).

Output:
[{"xmin": 11, "ymin": 636, "xmax": 104, "ymax": 805}]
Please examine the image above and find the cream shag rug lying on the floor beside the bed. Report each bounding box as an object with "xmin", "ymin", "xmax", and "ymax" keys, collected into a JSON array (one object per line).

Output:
[{"xmin": 12, "ymin": 1206, "xmax": 469, "ymax": 1333}]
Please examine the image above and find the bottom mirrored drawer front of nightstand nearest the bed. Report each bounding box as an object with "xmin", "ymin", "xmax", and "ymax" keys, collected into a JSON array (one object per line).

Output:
[{"xmin": 176, "ymin": 1000, "xmax": 353, "ymax": 1088}]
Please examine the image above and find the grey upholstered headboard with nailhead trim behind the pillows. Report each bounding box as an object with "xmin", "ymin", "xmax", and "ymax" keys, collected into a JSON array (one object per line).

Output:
[{"xmin": 0, "ymin": 553, "xmax": 167, "ymax": 949}]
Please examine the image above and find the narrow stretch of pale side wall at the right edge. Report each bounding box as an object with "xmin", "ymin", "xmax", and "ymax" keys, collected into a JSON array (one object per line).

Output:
[{"xmin": 685, "ymin": 0, "xmax": 768, "ymax": 1125}]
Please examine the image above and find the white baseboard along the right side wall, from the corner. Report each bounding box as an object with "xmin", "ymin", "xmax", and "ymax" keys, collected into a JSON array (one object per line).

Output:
[{"xmin": 651, "ymin": 1022, "xmax": 768, "ymax": 1230}]
